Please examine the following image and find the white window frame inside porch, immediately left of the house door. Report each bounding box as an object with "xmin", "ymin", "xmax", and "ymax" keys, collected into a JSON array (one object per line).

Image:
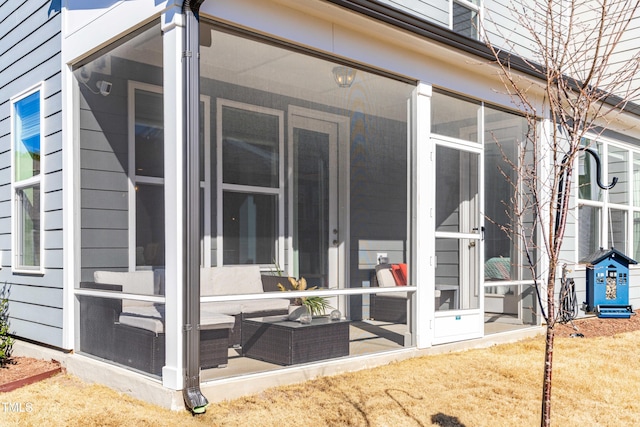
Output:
[{"xmin": 216, "ymin": 98, "xmax": 285, "ymax": 271}]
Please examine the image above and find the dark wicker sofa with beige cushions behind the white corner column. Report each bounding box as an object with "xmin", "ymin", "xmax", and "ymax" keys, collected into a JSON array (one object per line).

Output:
[{"xmin": 80, "ymin": 270, "xmax": 234, "ymax": 375}]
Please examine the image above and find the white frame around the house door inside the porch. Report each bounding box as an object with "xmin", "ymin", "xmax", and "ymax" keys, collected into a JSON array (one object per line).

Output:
[{"xmin": 285, "ymin": 105, "xmax": 350, "ymax": 294}]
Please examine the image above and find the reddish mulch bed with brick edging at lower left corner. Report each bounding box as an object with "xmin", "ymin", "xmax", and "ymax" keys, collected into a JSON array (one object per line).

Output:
[{"xmin": 0, "ymin": 357, "xmax": 62, "ymax": 392}]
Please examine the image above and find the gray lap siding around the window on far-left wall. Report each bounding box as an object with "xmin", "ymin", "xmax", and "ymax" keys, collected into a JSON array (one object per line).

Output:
[{"xmin": 0, "ymin": 0, "xmax": 63, "ymax": 347}]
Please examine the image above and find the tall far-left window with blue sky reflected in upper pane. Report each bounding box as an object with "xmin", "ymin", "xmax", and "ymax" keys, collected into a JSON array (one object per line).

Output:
[{"xmin": 12, "ymin": 89, "xmax": 43, "ymax": 272}]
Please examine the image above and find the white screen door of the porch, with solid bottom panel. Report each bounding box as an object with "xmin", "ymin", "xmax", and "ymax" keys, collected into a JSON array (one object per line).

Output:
[{"xmin": 433, "ymin": 142, "xmax": 484, "ymax": 344}]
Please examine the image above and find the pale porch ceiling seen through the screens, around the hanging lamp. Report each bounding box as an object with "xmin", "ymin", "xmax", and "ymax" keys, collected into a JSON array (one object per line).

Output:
[{"xmin": 112, "ymin": 22, "xmax": 407, "ymax": 121}]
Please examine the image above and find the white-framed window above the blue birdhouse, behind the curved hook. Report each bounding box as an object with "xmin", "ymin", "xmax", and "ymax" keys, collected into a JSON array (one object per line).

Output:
[{"xmin": 577, "ymin": 139, "xmax": 640, "ymax": 260}]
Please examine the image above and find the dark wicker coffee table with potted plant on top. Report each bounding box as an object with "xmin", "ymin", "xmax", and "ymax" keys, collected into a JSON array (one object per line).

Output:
[{"xmin": 242, "ymin": 316, "xmax": 350, "ymax": 365}]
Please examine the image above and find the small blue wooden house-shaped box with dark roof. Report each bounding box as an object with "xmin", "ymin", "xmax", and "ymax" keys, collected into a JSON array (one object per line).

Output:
[{"xmin": 581, "ymin": 248, "xmax": 637, "ymax": 319}]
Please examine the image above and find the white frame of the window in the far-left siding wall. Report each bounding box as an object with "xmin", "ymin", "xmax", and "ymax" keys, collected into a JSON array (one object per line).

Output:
[{"xmin": 10, "ymin": 82, "xmax": 45, "ymax": 275}]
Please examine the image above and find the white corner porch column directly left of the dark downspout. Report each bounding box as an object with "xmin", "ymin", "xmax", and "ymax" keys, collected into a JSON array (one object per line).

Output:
[{"xmin": 162, "ymin": 4, "xmax": 185, "ymax": 390}]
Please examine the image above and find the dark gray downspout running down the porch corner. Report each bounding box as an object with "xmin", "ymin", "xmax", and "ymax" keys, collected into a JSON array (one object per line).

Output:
[{"xmin": 182, "ymin": 0, "xmax": 209, "ymax": 414}]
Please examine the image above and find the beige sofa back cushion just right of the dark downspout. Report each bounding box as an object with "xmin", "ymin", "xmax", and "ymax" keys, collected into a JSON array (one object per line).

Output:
[{"xmin": 200, "ymin": 265, "xmax": 263, "ymax": 295}]
